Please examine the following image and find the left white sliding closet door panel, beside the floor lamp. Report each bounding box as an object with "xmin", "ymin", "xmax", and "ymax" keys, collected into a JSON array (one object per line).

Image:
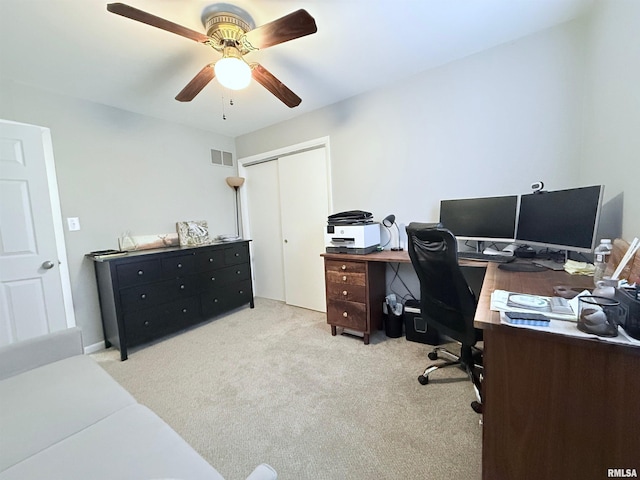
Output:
[{"xmin": 244, "ymin": 161, "xmax": 285, "ymax": 301}]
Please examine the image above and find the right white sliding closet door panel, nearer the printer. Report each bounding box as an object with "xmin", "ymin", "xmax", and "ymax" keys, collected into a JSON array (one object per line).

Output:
[{"xmin": 278, "ymin": 148, "xmax": 329, "ymax": 312}]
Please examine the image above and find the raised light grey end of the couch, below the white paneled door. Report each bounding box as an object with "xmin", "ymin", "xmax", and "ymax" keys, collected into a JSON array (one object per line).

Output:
[{"xmin": 0, "ymin": 327, "xmax": 83, "ymax": 380}]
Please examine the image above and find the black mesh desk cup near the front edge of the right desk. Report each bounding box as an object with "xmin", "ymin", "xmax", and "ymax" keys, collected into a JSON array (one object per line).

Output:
[{"xmin": 578, "ymin": 295, "xmax": 624, "ymax": 337}]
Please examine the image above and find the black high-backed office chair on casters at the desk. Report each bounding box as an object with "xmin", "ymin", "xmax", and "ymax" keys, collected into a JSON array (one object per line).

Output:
[{"xmin": 407, "ymin": 222, "xmax": 482, "ymax": 413}]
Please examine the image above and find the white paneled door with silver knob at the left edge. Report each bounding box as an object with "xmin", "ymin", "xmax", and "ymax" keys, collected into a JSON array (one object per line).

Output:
[{"xmin": 0, "ymin": 121, "xmax": 75, "ymax": 345}]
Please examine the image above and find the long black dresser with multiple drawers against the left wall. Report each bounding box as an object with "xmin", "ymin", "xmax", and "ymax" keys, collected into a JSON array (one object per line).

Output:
[{"xmin": 94, "ymin": 240, "xmax": 254, "ymax": 360}]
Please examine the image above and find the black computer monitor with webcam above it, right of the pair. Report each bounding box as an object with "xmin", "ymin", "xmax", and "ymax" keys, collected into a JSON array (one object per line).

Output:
[{"xmin": 516, "ymin": 185, "xmax": 604, "ymax": 253}]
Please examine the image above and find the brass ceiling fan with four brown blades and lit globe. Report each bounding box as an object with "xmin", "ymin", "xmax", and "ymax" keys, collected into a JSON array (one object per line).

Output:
[{"xmin": 107, "ymin": 3, "xmax": 318, "ymax": 108}]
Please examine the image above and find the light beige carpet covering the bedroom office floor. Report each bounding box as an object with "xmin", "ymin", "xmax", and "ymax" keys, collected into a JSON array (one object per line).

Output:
[{"xmin": 92, "ymin": 298, "xmax": 482, "ymax": 480}]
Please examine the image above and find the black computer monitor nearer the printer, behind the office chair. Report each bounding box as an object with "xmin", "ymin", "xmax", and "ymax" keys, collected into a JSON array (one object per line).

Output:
[{"xmin": 440, "ymin": 195, "xmax": 518, "ymax": 242}]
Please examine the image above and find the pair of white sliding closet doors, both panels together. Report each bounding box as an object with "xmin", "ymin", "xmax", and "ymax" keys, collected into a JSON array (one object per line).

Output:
[{"xmin": 243, "ymin": 147, "xmax": 330, "ymax": 312}]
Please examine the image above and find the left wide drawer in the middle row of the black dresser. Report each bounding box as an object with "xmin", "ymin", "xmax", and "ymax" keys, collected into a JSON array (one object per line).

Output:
[{"xmin": 120, "ymin": 277, "xmax": 198, "ymax": 312}]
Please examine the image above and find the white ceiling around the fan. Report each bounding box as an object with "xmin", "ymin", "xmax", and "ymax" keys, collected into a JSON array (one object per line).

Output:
[{"xmin": 0, "ymin": 0, "xmax": 593, "ymax": 137}]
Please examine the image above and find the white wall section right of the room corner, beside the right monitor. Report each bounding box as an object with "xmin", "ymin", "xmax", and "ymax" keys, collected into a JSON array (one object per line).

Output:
[{"xmin": 580, "ymin": 0, "xmax": 640, "ymax": 241}]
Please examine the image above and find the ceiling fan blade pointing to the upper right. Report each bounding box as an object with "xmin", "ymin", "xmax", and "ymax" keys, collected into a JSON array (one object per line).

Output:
[{"xmin": 245, "ymin": 9, "xmax": 318, "ymax": 48}]
